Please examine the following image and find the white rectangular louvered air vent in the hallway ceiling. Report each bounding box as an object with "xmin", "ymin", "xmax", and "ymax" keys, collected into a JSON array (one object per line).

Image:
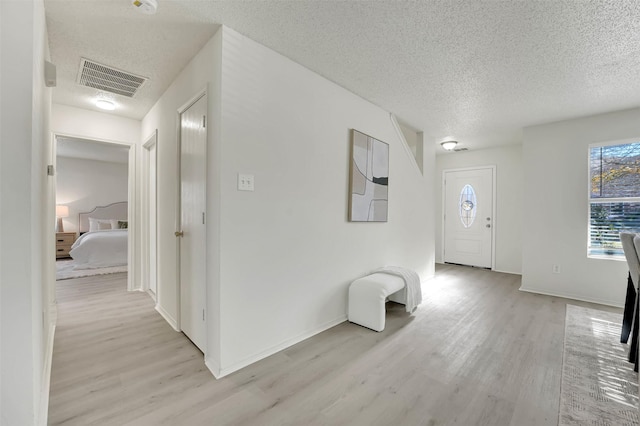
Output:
[{"xmin": 77, "ymin": 58, "xmax": 147, "ymax": 98}]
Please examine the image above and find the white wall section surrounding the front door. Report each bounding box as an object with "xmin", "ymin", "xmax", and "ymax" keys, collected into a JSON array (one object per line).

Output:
[{"xmin": 434, "ymin": 145, "xmax": 523, "ymax": 274}]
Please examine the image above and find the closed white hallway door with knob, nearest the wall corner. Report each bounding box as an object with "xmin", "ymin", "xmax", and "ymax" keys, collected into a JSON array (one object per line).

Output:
[{"xmin": 178, "ymin": 95, "xmax": 207, "ymax": 352}]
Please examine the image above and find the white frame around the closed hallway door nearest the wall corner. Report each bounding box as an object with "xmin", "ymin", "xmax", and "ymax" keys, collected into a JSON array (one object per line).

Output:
[{"xmin": 174, "ymin": 86, "xmax": 210, "ymax": 340}]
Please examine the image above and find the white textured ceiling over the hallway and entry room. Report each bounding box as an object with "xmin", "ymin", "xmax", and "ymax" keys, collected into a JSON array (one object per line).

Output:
[{"xmin": 45, "ymin": 0, "xmax": 640, "ymax": 149}]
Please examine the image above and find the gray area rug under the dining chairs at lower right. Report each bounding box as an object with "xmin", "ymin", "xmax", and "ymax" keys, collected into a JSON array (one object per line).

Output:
[{"xmin": 558, "ymin": 305, "xmax": 640, "ymax": 426}]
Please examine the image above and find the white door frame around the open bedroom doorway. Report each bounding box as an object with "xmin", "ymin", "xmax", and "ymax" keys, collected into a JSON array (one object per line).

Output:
[{"xmin": 53, "ymin": 133, "xmax": 139, "ymax": 291}]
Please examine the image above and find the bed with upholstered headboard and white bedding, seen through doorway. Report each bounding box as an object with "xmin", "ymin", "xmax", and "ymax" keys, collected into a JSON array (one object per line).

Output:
[{"xmin": 69, "ymin": 201, "xmax": 129, "ymax": 269}]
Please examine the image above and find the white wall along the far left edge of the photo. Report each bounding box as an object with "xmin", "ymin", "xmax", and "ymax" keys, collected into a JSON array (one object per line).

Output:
[{"xmin": 0, "ymin": 1, "xmax": 53, "ymax": 425}]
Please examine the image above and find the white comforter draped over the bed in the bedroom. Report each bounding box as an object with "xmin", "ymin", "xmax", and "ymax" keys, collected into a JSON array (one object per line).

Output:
[{"xmin": 69, "ymin": 229, "xmax": 128, "ymax": 269}]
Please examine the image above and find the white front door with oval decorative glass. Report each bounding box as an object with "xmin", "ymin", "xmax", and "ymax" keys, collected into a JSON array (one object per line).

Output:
[{"xmin": 443, "ymin": 167, "xmax": 495, "ymax": 268}]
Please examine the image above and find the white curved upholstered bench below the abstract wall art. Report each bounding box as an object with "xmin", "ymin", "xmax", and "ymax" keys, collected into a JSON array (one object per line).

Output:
[{"xmin": 348, "ymin": 273, "xmax": 405, "ymax": 331}]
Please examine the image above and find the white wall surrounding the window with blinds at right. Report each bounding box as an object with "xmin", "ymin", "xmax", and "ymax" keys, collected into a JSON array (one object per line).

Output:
[{"xmin": 522, "ymin": 109, "xmax": 640, "ymax": 306}]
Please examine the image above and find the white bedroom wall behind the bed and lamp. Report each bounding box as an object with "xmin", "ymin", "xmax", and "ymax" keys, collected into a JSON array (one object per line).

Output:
[{"xmin": 56, "ymin": 156, "xmax": 129, "ymax": 232}]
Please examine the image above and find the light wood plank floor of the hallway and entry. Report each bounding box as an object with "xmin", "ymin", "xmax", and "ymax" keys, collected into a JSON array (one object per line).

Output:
[{"xmin": 49, "ymin": 265, "xmax": 621, "ymax": 426}]
